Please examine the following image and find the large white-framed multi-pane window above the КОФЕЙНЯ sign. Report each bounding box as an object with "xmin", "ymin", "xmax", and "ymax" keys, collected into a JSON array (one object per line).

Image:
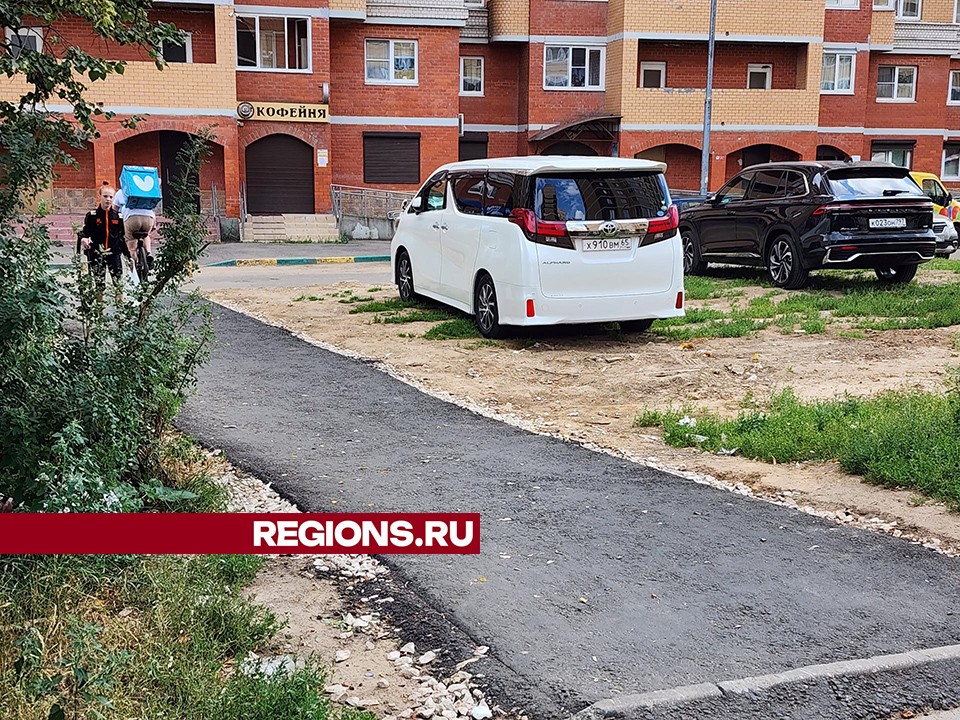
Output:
[{"xmin": 234, "ymin": 15, "xmax": 310, "ymax": 72}]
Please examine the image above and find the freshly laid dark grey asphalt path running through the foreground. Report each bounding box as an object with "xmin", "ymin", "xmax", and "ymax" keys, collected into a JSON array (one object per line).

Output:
[{"xmin": 179, "ymin": 307, "xmax": 960, "ymax": 718}]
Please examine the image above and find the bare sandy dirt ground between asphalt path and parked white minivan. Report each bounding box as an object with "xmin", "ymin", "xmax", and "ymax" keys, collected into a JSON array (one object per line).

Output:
[{"xmin": 208, "ymin": 283, "xmax": 960, "ymax": 548}]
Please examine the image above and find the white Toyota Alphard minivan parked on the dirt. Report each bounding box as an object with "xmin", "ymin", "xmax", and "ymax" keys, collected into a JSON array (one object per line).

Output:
[{"xmin": 390, "ymin": 156, "xmax": 683, "ymax": 337}]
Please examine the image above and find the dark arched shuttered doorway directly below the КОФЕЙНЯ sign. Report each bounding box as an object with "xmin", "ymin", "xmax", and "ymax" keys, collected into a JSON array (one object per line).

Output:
[{"xmin": 246, "ymin": 135, "xmax": 315, "ymax": 215}]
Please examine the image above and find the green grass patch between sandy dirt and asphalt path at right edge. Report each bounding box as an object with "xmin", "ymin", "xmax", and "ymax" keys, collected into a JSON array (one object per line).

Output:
[{"xmin": 635, "ymin": 380, "xmax": 960, "ymax": 507}]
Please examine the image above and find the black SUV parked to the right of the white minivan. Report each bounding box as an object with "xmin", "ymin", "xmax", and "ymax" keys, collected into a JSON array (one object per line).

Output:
[{"xmin": 680, "ymin": 161, "xmax": 937, "ymax": 289}]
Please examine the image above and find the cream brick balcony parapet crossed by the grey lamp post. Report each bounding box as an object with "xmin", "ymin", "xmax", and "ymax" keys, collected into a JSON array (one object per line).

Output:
[{"xmin": 621, "ymin": 88, "xmax": 820, "ymax": 131}]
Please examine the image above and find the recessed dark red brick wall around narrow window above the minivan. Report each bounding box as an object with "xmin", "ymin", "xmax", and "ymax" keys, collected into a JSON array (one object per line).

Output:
[{"xmin": 457, "ymin": 43, "xmax": 521, "ymax": 125}]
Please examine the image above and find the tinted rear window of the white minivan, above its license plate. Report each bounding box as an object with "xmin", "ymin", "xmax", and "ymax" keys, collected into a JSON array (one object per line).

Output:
[{"xmin": 534, "ymin": 173, "xmax": 670, "ymax": 222}]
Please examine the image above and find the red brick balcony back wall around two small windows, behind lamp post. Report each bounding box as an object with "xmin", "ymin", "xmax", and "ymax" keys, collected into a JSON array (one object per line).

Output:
[{"xmin": 637, "ymin": 42, "xmax": 806, "ymax": 90}]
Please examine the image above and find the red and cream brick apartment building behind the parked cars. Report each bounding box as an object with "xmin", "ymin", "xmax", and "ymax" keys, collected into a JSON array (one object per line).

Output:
[{"xmin": 6, "ymin": 0, "xmax": 960, "ymax": 226}]
